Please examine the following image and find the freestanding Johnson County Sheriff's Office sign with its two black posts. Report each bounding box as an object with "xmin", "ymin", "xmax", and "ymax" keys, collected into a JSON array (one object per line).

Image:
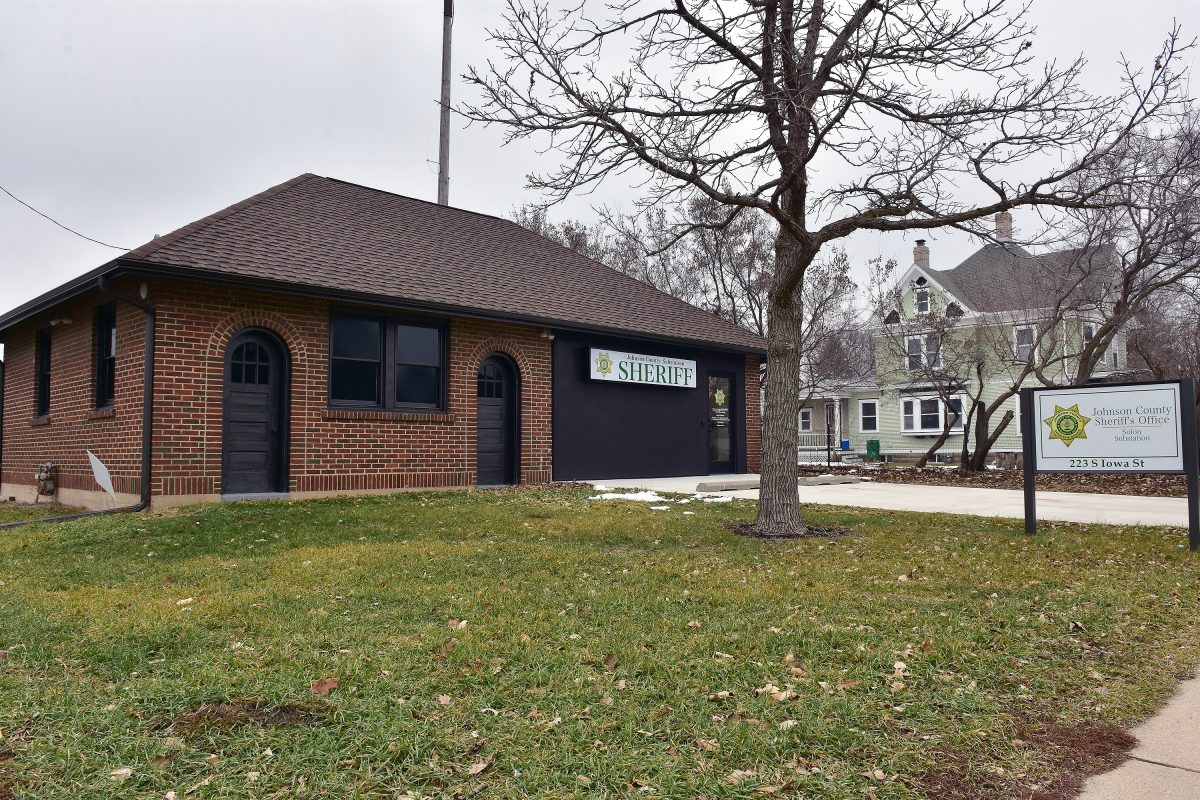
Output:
[{"xmin": 1021, "ymin": 379, "xmax": 1200, "ymax": 551}]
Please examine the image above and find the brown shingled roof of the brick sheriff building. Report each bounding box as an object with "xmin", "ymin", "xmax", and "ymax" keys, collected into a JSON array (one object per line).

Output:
[{"xmin": 121, "ymin": 175, "xmax": 766, "ymax": 351}]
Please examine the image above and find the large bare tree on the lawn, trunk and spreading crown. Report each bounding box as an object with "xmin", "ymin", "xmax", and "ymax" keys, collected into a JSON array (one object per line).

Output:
[{"xmin": 460, "ymin": 0, "xmax": 1182, "ymax": 534}]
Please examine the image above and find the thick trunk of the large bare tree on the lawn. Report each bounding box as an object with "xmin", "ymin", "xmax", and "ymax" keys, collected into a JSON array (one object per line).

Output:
[{"xmin": 756, "ymin": 233, "xmax": 811, "ymax": 535}]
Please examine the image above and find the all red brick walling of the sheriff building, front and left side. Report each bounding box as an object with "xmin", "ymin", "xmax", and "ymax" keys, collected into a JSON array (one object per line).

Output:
[{"xmin": 0, "ymin": 273, "xmax": 761, "ymax": 497}]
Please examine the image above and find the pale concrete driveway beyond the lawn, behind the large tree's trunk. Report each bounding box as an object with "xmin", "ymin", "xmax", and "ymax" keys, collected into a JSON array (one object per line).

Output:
[{"xmin": 589, "ymin": 475, "xmax": 1180, "ymax": 527}]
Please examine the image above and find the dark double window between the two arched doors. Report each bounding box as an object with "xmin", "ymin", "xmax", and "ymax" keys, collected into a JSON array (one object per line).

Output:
[{"xmin": 329, "ymin": 314, "xmax": 445, "ymax": 410}]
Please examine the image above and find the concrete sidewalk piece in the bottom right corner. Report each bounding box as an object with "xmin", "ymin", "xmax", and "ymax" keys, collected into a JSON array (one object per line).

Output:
[{"xmin": 1079, "ymin": 679, "xmax": 1200, "ymax": 800}]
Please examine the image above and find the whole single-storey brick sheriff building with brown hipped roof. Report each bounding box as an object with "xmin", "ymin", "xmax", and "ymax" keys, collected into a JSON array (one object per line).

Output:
[{"xmin": 0, "ymin": 175, "xmax": 763, "ymax": 507}]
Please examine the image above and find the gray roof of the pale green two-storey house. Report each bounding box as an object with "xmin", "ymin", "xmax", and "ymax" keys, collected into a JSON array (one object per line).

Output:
[{"xmin": 929, "ymin": 242, "xmax": 1114, "ymax": 312}]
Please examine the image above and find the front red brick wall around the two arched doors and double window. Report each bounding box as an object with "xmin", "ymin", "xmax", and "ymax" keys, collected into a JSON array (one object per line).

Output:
[{"xmin": 154, "ymin": 282, "xmax": 552, "ymax": 494}]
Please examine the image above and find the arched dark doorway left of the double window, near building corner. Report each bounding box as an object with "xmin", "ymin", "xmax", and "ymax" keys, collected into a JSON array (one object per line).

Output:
[{"xmin": 221, "ymin": 329, "xmax": 288, "ymax": 495}]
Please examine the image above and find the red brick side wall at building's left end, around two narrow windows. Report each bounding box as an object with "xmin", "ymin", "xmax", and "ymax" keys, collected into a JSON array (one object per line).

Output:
[{"xmin": 0, "ymin": 280, "xmax": 145, "ymax": 494}]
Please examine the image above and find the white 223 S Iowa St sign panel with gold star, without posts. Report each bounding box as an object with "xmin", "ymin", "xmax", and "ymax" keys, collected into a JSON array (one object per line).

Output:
[{"xmin": 1026, "ymin": 384, "xmax": 1183, "ymax": 473}]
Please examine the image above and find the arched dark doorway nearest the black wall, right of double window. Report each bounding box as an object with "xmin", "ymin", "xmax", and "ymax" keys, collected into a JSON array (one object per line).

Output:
[{"xmin": 475, "ymin": 354, "xmax": 521, "ymax": 486}]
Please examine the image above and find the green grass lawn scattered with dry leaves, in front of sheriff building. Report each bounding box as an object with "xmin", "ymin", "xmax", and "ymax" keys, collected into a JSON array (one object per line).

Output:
[{"xmin": 0, "ymin": 489, "xmax": 1200, "ymax": 800}]
